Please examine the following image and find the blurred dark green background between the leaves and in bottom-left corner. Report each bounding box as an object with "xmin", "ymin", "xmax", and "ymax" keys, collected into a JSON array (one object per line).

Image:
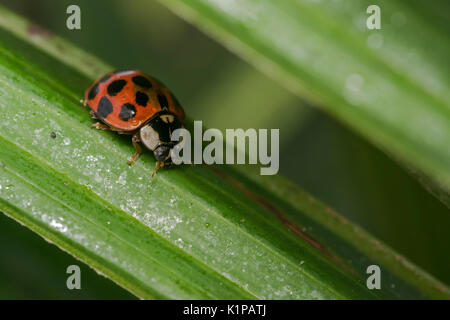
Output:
[{"xmin": 0, "ymin": 0, "xmax": 450, "ymax": 299}]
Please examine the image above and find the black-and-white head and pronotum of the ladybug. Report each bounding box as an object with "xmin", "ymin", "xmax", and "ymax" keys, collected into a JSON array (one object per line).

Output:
[{"xmin": 139, "ymin": 111, "xmax": 182, "ymax": 165}]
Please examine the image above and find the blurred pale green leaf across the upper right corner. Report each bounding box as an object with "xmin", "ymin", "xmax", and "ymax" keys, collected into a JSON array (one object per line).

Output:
[{"xmin": 161, "ymin": 0, "xmax": 450, "ymax": 206}]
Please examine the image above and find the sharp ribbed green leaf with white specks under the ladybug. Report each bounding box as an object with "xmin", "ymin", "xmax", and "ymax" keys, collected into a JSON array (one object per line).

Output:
[{"xmin": 0, "ymin": 8, "xmax": 450, "ymax": 299}]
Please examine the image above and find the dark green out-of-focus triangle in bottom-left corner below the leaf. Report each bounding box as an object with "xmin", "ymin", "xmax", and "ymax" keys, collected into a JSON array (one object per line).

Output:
[{"xmin": 0, "ymin": 214, "xmax": 135, "ymax": 300}]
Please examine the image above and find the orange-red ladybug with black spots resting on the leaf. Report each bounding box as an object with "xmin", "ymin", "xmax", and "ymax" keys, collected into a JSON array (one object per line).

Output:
[{"xmin": 83, "ymin": 70, "xmax": 185, "ymax": 176}]
